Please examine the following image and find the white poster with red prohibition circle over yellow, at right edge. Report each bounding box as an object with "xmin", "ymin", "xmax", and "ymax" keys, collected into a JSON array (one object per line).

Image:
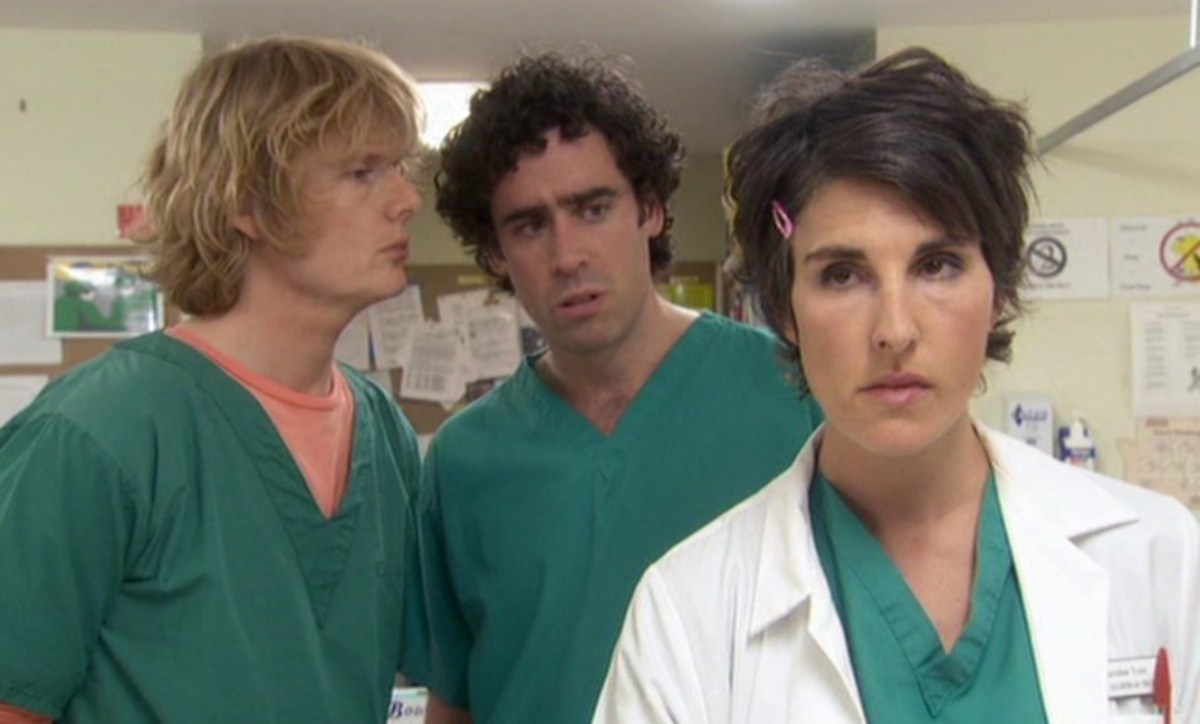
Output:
[{"xmin": 1110, "ymin": 216, "xmax": 1200, "ymax": 297}]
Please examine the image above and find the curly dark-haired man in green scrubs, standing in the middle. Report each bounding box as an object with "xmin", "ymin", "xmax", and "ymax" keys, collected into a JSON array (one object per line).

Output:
[{"xmin": 414, "ymin": 54, "xmax": 818, "ymax": 724}]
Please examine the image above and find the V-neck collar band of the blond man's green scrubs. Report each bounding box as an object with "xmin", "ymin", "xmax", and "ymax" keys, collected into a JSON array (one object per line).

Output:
[{"xmin": 121, "ymin": 333, "xmax": 374, "ymax": 624}]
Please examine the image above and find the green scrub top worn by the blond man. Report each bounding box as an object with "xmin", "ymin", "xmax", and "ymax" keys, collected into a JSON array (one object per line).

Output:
[{"xmin": 0, "ymin": 334, "xmax": 424, "ymax": 724}]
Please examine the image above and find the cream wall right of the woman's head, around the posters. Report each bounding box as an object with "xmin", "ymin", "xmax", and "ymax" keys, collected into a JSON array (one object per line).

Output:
[{"xmin": 877, "ymin": 16, "xmax": 1200, "ymax": 475}]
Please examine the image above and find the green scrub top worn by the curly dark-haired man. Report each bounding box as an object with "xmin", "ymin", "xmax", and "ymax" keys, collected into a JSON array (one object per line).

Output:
[{"xmin": 413, "ymin": 315, "xmax": 820, "ymax": 724}]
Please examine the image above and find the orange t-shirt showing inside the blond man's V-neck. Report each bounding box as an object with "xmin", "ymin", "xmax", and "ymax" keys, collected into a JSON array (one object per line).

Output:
[{"xmin": 168, "ymin": 327, "xmax": 354, "ymax": 517}]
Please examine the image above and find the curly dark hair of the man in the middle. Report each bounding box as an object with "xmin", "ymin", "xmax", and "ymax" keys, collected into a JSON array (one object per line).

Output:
[{"xmin": 434, "ymin": 53, "xmax": 684, "ymax": 289}]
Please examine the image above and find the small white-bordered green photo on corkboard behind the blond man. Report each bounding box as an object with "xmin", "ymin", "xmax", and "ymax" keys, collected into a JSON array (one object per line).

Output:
[{"xmin": 46, "ymin": 256, "xmax": 163, "ymax": 337}]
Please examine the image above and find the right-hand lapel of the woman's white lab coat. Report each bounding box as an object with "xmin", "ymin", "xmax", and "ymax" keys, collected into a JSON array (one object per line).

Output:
[{"xmin": 983, "ymin": 430, "xmax": 1129, "ymax": 724}]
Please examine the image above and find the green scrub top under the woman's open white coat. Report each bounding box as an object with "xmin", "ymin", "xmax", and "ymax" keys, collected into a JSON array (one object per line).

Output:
[{"xmin": 809, "ymin": 473, "xmax": 1046, "ymax": 724}]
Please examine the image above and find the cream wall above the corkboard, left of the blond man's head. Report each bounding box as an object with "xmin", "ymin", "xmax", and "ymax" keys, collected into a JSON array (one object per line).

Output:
[{"xmin": 0, "ymin": 29, "xmax": 202, "ymax": 245}]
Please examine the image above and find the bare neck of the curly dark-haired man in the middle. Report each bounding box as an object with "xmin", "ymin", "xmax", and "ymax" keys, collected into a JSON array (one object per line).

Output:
[{"xmin": 538, "ymin": 298, "xmax": 698, "ymax": 435}]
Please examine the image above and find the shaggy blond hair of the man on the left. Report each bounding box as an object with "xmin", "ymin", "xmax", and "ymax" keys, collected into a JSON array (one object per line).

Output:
[{"xmin": 143, "ymin": 36, "xmax": 424, "ymax": 315}]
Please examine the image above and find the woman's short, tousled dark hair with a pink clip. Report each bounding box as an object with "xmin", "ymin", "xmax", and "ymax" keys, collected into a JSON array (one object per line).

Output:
[{"xmin": 726, "ymin": 48, "xmax": 1033, "ymax": 389}]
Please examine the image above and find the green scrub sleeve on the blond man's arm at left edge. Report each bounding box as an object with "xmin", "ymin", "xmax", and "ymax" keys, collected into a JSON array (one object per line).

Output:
[{"xmin": 0, "ymin": 415, "xmax": 136, "ymax": 717}]
